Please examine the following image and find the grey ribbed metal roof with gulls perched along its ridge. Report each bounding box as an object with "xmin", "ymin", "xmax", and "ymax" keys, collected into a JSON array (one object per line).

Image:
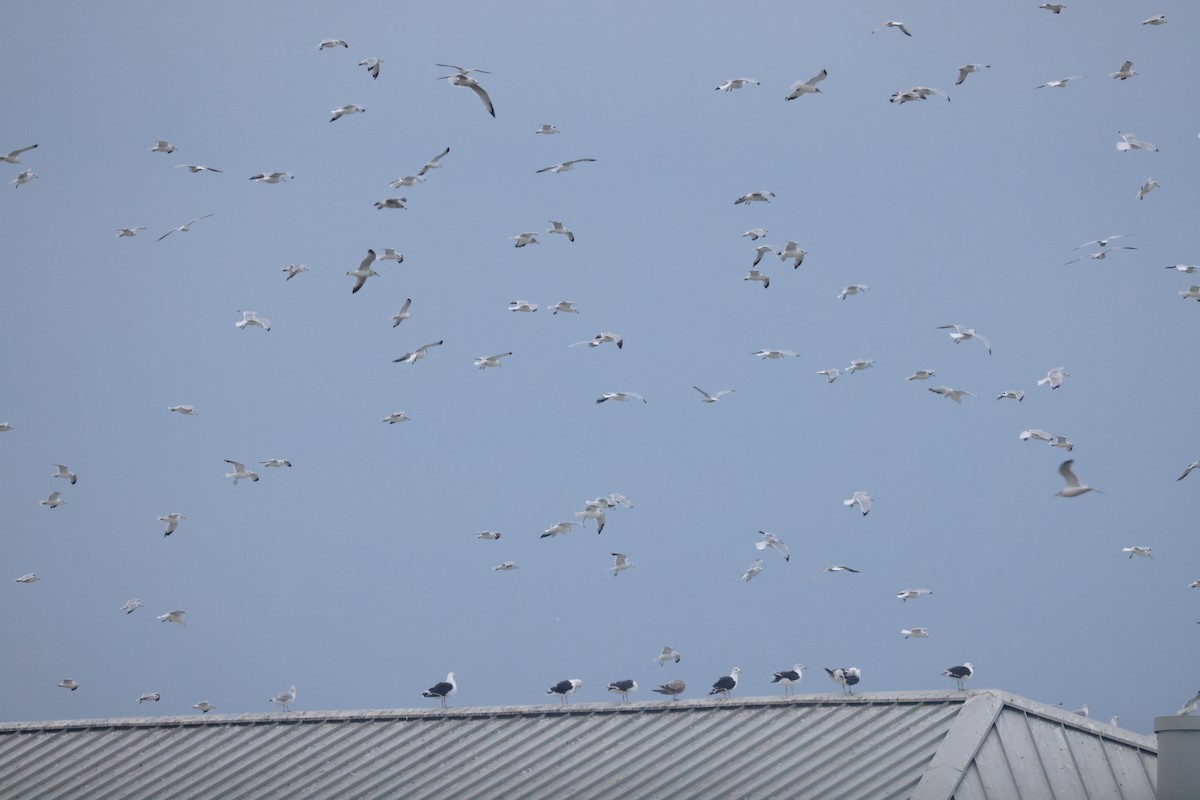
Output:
[{"xmin": 0, "ymin": 690, "xmax": 1157, "ymax": 800}]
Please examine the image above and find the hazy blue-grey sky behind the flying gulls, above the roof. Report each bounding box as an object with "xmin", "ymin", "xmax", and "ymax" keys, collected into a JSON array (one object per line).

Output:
[{"xmin": 0, "ymin": 0, "xmax": 1200, "ymax": 732}]
